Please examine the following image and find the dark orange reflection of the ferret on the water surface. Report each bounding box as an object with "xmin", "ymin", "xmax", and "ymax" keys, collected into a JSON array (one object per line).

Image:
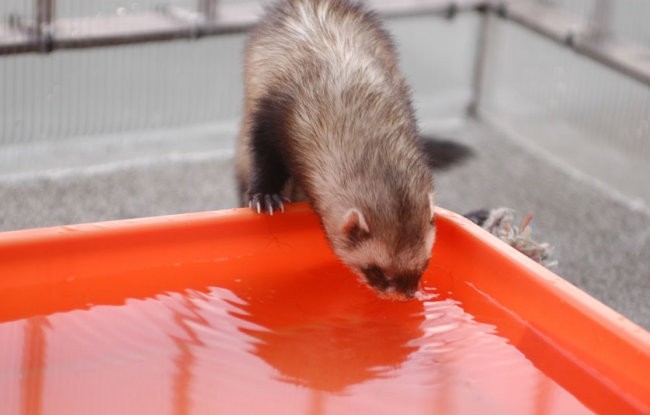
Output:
[{"xmin": 230, "ymin": 264, "xmax": 424, "ymax": 393}]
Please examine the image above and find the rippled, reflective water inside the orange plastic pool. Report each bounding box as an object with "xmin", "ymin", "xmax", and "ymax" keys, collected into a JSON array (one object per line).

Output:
[{"xmin": 0, "ymin": 265, "xmax": 589, "ymax": 415}]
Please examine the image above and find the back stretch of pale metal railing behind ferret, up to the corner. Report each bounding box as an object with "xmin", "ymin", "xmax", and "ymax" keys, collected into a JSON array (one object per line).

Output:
[{"xmin": 0, "ymin": 0, "xmax": 484, "ymax": 55}]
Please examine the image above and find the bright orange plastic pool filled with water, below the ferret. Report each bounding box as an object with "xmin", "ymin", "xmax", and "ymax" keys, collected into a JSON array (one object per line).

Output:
[{"xmin": 0, "ymin": 205, "xmax": 650, "ymax": 415}]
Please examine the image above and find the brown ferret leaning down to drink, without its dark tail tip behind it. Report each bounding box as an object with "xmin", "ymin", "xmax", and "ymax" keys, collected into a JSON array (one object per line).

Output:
[{"xmin": 235, "ymin": 0, "xmax": 436, "ymax": 300}]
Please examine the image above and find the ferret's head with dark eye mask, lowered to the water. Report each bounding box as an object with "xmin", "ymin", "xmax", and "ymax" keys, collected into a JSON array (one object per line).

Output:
[{"xmin": 326, "ymin": 192, "xmax": 435, "ymax": 300}]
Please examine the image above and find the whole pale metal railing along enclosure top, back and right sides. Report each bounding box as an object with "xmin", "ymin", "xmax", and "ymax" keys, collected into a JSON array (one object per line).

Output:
[{"xmin": 0, "ymin": 0, "xmax": 650, "ymax": 86}]
